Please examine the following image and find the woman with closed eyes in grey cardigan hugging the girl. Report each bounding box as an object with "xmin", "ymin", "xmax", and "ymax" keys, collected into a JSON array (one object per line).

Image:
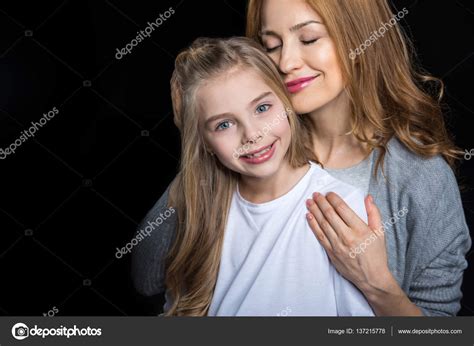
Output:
[{"xmin": 134, "ymin": 0, "xmax": 471, "ymax": 316}]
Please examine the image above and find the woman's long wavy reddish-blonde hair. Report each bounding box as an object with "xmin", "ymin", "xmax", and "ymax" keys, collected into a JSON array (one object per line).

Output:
[{"xmin": 247, "ymin": 0, "xmax": 461, "ymax": 172}]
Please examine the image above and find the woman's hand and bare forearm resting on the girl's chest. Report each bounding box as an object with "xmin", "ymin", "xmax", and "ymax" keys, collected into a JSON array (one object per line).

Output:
[{"xmin": 306, "ymin": 192, "xmax": 422, "ymax": 316}]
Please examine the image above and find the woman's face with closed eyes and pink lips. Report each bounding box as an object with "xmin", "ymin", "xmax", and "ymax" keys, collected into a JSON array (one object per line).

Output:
[{"xmin": 261, "ymin": 0, "xmax": 344, "ymax": 114}]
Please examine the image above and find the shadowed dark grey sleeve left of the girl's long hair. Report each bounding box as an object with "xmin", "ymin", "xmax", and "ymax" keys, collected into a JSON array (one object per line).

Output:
[{"xmin": 132, "ymin": 186, "xmax": 177, "ymax": 296}]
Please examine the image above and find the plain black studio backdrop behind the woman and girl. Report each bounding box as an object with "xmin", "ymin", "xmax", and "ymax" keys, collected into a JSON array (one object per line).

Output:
[{"xmin": 0, "ymin": 0, "xmax": 474, "ymax": 316}]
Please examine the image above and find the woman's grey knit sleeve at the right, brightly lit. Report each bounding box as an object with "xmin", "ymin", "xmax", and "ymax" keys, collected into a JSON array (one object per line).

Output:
[{"xmin": 407, "ymin": 158, "xmax": 471, "ymax": 316}]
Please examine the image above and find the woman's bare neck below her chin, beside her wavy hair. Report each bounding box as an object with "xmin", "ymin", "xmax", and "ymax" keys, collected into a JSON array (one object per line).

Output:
[{"xmin": 307, "ymin": 92, "xmax": 368, "ymax": 169}]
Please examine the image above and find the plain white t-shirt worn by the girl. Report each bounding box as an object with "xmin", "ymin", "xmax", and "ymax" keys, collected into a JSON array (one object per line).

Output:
[{"xmin": 208, "ymin": 163, "xmax": 374, "ymax": 316}]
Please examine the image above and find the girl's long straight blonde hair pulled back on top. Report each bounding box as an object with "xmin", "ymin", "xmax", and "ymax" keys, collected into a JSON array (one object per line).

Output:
[{"xmin": 165, "ymin": 37, "xmax": 317, "ymax": 316}]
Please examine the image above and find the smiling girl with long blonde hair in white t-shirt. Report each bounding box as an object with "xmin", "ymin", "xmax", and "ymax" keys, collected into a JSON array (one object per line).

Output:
[{"xmin": 165, "ymin": 38, "xmax": 373, "ymax": 316}]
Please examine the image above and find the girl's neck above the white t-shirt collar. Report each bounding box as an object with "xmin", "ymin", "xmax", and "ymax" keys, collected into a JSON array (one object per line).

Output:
[{"xmin": 239, "ymin": 160, "xmax": 309, "ymax": 203}]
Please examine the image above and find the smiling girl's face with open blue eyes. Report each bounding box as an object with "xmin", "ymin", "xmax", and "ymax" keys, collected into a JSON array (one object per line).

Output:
[{"xmin": 197, "ymin": 68, "xmax": 291, "ymax": 178}]
